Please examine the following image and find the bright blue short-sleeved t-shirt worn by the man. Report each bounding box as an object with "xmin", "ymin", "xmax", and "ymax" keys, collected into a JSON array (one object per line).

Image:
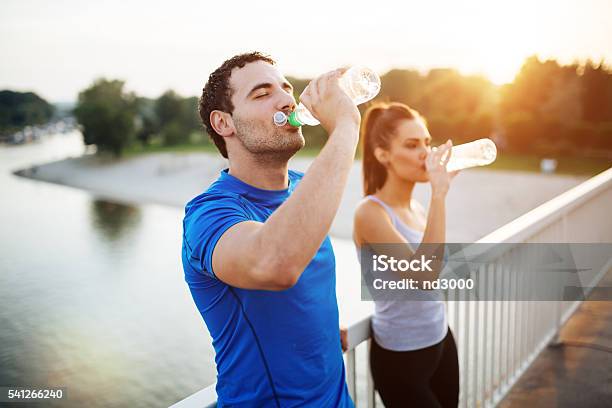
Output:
[{"xmin": 182, "ymin": 169, "xmax": 353, "ymax": 407}]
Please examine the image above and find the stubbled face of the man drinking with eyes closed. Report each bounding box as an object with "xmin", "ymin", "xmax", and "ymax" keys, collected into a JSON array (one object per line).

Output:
[{"xmin": 230, "ymin": 61, "xmax": 304, "ymax": 160}]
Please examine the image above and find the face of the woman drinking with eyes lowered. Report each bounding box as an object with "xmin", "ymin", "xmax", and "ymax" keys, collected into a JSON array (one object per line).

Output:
[{"xmin": 377, "ymin": 119, "xmax": 431, "ymax": 182}]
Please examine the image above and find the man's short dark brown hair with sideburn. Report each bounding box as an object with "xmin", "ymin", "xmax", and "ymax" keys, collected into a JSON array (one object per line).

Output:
[{"xmin": 198, "ymin": 51, "xmax": 276, "ymax": 159}]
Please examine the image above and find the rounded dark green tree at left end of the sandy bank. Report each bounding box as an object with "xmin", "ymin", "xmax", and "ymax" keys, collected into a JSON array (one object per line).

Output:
[{"xmin": 74, "ymin": 78, "xmax": 136, "ymax": 157}]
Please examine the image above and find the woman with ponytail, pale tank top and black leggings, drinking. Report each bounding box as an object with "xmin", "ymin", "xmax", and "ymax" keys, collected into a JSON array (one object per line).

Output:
[{"xmin": 353, "ymin": 103, "xmax": 459, "ymax": 408}]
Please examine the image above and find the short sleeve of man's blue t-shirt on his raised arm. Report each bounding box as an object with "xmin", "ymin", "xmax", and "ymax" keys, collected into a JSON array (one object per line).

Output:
[{"xmin": 183, "ymin": 194, "xmax": 249, "ymax": 278}]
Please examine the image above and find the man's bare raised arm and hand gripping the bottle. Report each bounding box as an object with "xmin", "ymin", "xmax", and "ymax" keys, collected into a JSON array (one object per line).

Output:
[{"xmin": 212, "ymin": 70, "xmax": 360, "ymax": 290}]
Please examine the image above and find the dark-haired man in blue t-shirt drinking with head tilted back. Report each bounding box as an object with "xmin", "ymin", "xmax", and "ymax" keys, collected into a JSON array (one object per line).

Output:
[{"xmin": 182, "ymin": 52, "xmax": 360, "ymax": 407}]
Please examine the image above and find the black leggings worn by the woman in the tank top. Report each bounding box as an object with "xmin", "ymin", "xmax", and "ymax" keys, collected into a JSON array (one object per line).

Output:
[{"xmin": 370, "ymin": 328, "xmax": 459, "ymax": 408}]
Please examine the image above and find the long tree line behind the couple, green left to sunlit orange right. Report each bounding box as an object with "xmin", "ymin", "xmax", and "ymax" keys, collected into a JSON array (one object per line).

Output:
[{"xmin": 75, "ymin": 56, "xmax": 612, "ymax": 155}]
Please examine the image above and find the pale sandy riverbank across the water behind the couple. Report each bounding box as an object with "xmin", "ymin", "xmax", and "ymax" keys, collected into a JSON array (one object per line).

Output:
[{"xmin": 17, "ymin": 147, "xmax": 587, "ymax": 242}]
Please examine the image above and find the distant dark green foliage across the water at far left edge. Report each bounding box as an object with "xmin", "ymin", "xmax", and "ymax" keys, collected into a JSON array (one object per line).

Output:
[{"xmin": 0, "ymin": 90, "xmax": 54, "ymax": 133}]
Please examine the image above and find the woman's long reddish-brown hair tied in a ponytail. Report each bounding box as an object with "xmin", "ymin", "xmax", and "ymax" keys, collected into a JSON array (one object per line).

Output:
[{"xmin": 361, "ymin": 102, "xmax": 423, "ymax": 195}]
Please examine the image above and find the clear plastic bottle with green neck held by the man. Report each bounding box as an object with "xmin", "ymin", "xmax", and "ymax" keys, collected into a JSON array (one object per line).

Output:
[{"xmin": 273, "ymin": 67, "xmax": 380, "ymax": 127}]
